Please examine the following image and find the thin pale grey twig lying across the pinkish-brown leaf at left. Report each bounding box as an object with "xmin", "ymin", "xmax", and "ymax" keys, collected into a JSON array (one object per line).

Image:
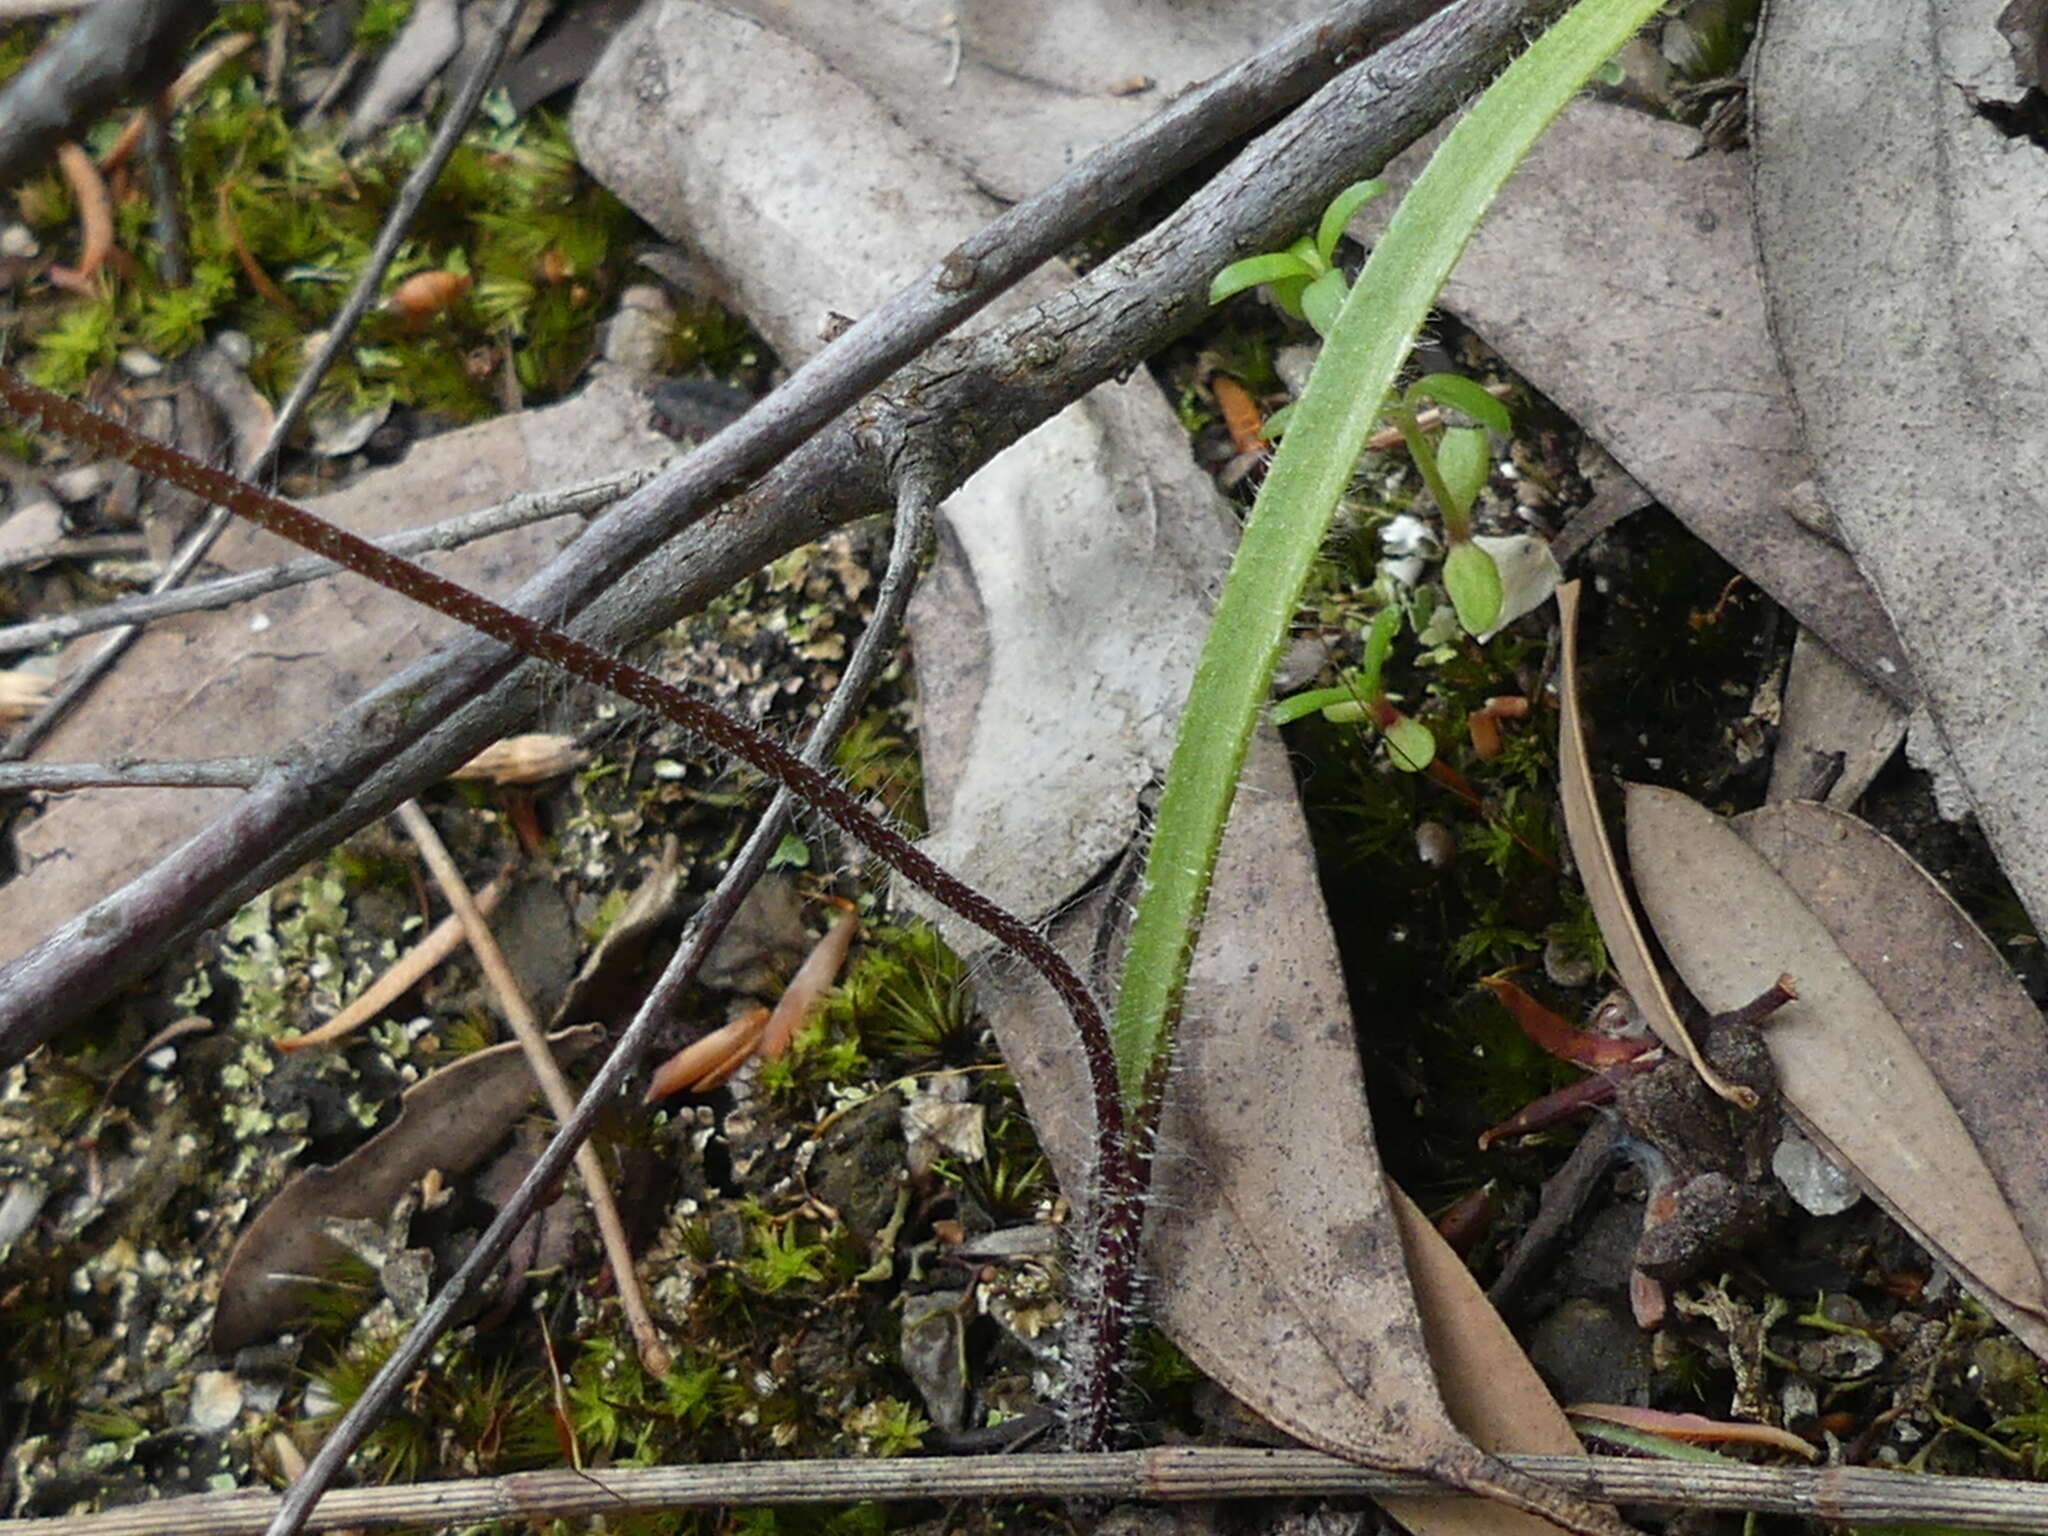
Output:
[{"xmin": 0, "ymin": 456, "xmax": 659, "ymax": 653}]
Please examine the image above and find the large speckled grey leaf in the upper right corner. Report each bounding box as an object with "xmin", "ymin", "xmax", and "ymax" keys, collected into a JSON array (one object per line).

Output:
[{"xmin": 1751, "ymin": 0, "xmax": 2048, "ymax": 932}]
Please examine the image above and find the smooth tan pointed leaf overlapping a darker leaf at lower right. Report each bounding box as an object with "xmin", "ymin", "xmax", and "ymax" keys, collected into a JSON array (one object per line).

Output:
[{"xmin": 1628, "ymin": 784, "xmax": 2048, "ymax": 1358}]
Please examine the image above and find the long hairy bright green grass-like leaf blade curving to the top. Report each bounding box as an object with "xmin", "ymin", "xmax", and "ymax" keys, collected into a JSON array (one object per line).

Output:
[{"xmin": 1112, "ymin": 0, "xmax": 1661, "ymax": 1112}]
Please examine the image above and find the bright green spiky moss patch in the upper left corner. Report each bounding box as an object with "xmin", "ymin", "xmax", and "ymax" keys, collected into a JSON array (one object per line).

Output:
[{"xmin": 0, "ymin": 6, "xmax": 655, "ymax": 422}]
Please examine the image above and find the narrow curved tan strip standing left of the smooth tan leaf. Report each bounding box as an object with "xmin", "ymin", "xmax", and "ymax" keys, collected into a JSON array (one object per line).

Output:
[{"xmin": 1556, "ymin": 582, "xmax": 1757, "ymax": 1110}]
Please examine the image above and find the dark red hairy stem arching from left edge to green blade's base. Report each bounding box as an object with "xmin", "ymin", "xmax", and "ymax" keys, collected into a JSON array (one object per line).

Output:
[{"xmin": 0, "ymin": 369, "xmax": 1130, "ymax": 1245}]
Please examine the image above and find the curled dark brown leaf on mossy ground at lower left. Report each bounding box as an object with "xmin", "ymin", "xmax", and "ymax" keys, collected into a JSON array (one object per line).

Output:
[{"xmin": 213, "ymin": 1024, "xmax": 604, "ymax": 1354}]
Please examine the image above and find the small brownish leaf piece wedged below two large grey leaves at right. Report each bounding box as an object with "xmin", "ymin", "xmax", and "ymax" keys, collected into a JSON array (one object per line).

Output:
[{"xmin": 1765, "ymin": 629, "xmax": 1907, "ymax": 811}]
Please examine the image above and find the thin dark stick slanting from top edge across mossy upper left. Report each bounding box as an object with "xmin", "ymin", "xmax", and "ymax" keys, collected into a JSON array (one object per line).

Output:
[{"xmin": 0, "ymin": 0, "xmax": 540, "ymax": 760}]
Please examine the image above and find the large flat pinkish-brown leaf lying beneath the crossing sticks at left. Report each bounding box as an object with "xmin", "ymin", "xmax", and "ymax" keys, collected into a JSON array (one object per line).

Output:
[{"xmin": 0, "ymin": 373, "xmax": 674, "ymax": 961}]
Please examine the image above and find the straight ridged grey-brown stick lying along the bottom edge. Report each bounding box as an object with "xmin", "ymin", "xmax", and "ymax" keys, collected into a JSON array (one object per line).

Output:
[{"xmin": 12, "ymin": 1446, "xmax": 2048, "ymax": 1536}]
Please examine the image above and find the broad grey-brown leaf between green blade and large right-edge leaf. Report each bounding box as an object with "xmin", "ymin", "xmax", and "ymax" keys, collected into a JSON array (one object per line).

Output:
[{"xmin": 1352, "ymin": 98, "xmax": 1911, "ymax": 698}]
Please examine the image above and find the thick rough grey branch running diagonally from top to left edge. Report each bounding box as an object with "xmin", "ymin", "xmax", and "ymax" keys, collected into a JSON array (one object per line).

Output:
[{"xmin": 0, "ymin": 0, "xmax": 1563, "ymax": 1065}]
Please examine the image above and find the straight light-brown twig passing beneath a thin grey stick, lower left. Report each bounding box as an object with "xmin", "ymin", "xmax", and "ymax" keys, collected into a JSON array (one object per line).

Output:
[{"xmin": 397, "ymin": 801, "xmax": 676, "ymax": 1376}]
